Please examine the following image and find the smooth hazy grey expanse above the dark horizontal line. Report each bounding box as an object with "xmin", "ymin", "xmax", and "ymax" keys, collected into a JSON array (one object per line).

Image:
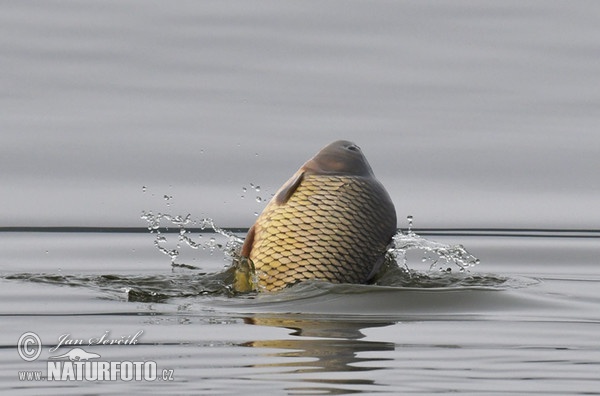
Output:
[{"xmin": 0, "ymin": 0, "xmax": 600, "ymax": 228}]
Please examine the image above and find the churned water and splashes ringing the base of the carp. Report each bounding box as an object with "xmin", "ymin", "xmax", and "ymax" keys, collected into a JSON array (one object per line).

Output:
[{"xmin": 0, "ymin": 211, "xmax": 496, "ymax": 310}]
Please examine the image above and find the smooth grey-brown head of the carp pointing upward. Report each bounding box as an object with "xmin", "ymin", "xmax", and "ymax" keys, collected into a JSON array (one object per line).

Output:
[{"xmin": 301, "ymin": 140, "xmax": 373, "ymax": 176}]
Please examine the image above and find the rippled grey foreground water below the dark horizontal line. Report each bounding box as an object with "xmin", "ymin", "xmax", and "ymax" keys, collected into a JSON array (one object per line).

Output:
[{"xmin": 0, "ymin": 230, "xmax": 600, "ymax": 395}]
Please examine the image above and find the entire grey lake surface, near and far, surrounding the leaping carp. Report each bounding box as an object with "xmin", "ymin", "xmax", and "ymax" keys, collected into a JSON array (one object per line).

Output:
[{"xmin": 0, "ymin": 0, "xmax": 600, "ymax": 395}]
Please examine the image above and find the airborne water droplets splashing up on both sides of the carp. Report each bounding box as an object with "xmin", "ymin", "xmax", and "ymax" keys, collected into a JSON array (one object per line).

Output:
[{"xmin": 141, "ymin": 183, "xmax": 482, "ymax": 290}]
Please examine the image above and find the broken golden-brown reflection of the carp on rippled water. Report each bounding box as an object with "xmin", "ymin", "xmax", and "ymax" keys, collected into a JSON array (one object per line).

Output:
[{"xmin": 242, "ymin": 316, "xmax": 395, "ymax": 394}]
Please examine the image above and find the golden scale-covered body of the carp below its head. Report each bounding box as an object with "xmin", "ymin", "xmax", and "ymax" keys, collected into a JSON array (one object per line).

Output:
[{"xmin": 250, "ymin": 175, "xmax": 395, "ymax": 291}]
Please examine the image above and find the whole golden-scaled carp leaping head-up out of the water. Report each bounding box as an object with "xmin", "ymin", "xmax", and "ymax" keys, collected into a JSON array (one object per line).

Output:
[{"xmin": 234, "ymin": 140, "xmax": 397, "ymax": 291}]
